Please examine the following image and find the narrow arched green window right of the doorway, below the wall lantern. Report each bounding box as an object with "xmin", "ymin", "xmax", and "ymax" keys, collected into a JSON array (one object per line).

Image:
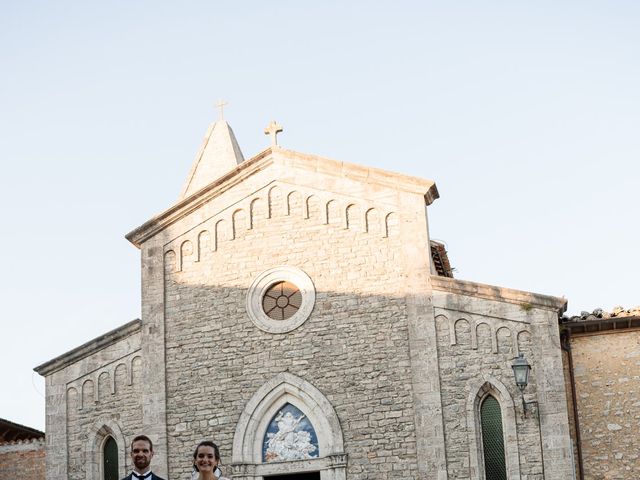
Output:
[{"xmin": 480, "ymin": 395, "xmax": 507, "ymax": 480}]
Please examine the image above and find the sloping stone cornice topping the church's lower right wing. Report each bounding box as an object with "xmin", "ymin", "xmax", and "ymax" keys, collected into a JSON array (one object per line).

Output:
[{"xmin": 431, "ymin": 275, "xmax": 567, "ymax": 314}]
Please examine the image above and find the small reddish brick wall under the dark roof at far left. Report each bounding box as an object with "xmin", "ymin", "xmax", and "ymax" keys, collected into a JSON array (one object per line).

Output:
[{"xmin": 0, "ymin": 439, "xmax": 45, "ymax": 480}]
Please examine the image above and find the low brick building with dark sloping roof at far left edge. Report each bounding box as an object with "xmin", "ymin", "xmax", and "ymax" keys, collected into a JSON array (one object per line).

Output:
[{"xmin": 0, "ymin": 418, "xmax": 45, "ymax": 480}]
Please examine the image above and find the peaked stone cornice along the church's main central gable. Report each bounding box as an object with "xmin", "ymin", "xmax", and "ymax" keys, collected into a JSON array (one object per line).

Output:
[{"xmin": 125, "ymin": 147, "xmax": 439, "ymax": 248}]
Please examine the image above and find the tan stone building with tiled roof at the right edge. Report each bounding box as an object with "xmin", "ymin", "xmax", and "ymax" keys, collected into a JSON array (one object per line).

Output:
[{"xmin": 561, "ymin": 307, "xmax": 640, "ymax": 480}]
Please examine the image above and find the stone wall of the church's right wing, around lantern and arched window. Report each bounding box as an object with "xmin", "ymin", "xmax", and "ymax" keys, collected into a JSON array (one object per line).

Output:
[{"xmin": 434, "ymin": 279, "xmax": 571, "ymax": 480}]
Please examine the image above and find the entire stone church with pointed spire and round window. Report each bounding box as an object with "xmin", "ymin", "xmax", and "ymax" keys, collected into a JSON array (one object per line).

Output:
[{"xmin": 36, "ymin": 111, "xmax": 573, "ymax": 480}]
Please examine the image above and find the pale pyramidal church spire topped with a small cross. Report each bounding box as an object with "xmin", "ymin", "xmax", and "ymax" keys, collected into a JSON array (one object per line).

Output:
[{"xmin": 180, "ymin": 102, "xmax": 244, "ymax": 199}]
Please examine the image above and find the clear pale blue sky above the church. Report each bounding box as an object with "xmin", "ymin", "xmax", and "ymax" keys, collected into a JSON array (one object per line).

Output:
[{"xmin": 0, "ymin": 0, "xmax": 640, "ymax": 429}]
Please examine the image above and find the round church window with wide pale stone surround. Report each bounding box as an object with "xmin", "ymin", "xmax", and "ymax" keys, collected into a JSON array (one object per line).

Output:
[{"xmin": 247, "ymin": 267, "xmax": 316, "ymax": 333}]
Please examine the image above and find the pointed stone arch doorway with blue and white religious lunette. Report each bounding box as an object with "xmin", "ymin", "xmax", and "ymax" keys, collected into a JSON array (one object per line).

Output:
[{"xmin": 232, "ymin": 372, "xmax": 347, "ymax": 480}]
